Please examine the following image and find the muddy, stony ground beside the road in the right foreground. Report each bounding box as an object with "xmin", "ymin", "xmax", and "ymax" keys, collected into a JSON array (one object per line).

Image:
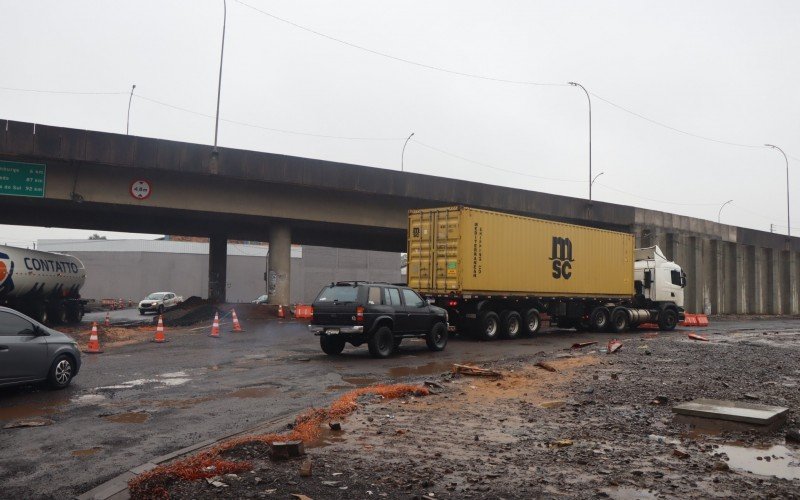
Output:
[{"xmin": 159, "ymin": 327, "xmax": 800, "ymax": 500}]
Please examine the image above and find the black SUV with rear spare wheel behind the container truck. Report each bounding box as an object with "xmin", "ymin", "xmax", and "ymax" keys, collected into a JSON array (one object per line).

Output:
[{"xmin": 308, "ymin": 281, "xmax": 448, "ymax": 358}]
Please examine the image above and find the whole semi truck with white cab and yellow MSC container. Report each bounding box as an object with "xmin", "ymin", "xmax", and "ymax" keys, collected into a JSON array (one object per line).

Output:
[{"xmin": 407, "ymin": 206, "xmax": 686, "ymax": 340}]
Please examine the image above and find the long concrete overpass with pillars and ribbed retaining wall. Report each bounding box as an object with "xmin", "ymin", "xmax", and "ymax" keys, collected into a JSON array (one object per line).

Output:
[{"xmin": 0, "ymin": 117, "xmax": 800, "ymax": 314}]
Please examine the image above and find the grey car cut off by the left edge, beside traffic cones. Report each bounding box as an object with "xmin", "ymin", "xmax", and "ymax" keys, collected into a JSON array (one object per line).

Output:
[{"xmin": 0, "ymin": 307, "xmax": 81, "ymax": 389}]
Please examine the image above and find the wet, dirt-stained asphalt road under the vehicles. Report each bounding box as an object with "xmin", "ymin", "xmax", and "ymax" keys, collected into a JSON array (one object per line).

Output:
[{"xmin": 0, "ymin": 320, "xmax": 798, "ymax": 498}]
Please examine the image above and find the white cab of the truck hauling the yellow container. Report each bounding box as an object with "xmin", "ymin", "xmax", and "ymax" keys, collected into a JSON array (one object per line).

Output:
[{"xmin": 633, "ymin": 246, "xmax": 686, "ymax": 308}]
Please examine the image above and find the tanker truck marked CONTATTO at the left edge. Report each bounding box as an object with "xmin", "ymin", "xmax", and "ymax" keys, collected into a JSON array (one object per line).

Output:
[{"xmin": 0, "ymin": 245, "xmax": 86, "ymax": 324}]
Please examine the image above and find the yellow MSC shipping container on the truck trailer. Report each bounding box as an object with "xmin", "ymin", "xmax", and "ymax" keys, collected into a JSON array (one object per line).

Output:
[{"xmin": 408, "ymin": 207, "xmax": 634, "ymax": 297}]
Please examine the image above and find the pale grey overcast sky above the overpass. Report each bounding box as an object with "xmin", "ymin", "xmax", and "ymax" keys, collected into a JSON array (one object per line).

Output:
[{"xmin": 0, "ymin": 0, "xmax": 800, "ymax": 244}]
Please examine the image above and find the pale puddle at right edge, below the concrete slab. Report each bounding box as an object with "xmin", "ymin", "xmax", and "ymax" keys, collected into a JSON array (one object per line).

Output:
[{"xmin": 714, "ymin": 445, "xmax": 800, "ymax": 479}]
